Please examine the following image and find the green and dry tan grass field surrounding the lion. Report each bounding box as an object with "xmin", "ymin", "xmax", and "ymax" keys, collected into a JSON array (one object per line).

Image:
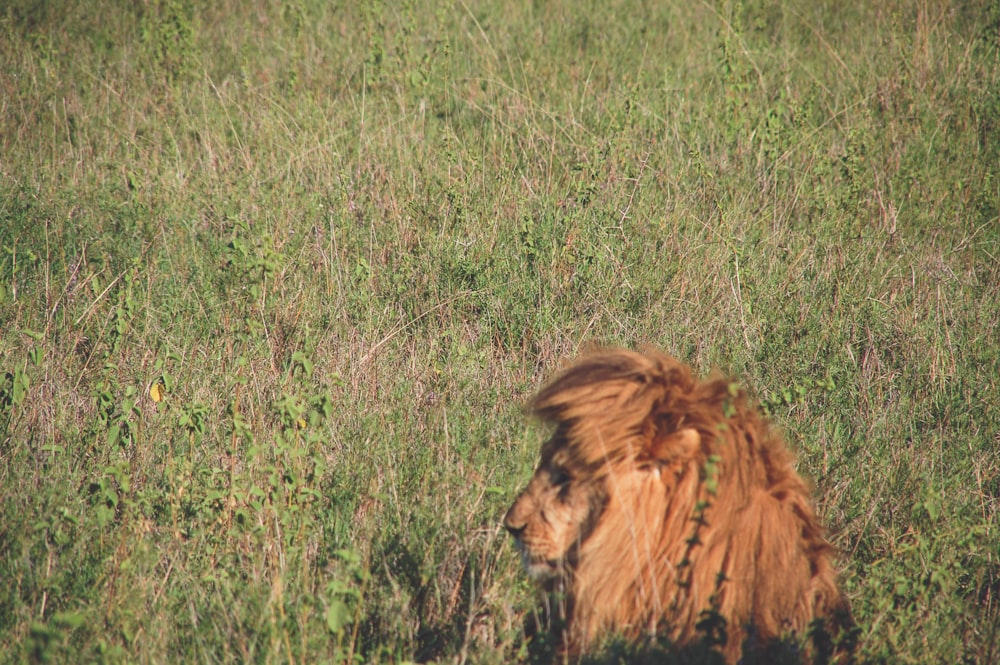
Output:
[{"xmin": 0, "ymin": 0, "xmax": 1000, "ymax": 665}]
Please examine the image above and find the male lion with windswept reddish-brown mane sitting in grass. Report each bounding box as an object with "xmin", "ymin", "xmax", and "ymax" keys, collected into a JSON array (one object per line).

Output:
[{"xmin": 504, "ymin": 350, "xmax": 851, "ymax": 663}]
